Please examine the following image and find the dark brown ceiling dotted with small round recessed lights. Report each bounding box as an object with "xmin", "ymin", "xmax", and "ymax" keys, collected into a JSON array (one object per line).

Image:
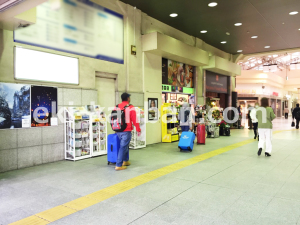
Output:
[{"xmin": 122, "ymin": 0, "xmax": 300, "ymax": 54}]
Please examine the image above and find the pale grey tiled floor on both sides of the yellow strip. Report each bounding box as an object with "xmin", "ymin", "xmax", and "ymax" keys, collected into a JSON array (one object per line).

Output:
[{"xmin": 0, "ymin": 119, "xmax": 300, "ymax": 225}]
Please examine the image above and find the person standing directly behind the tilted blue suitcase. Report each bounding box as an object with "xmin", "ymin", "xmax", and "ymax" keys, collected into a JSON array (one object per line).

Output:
[{"xmin": 179, "ymin": 102, "xmax": 194, "ymax": 132}]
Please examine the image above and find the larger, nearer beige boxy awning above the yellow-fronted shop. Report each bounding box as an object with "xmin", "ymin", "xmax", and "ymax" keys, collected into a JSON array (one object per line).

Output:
[{"xmin": 142, "ymin": 32, "xmax": 209, "ymax": 66}]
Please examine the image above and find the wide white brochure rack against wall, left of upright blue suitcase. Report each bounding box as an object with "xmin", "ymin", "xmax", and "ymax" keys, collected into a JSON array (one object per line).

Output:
[{"xmin": 64, "ymin": 107, "xmax": 107, "ymax": 161}]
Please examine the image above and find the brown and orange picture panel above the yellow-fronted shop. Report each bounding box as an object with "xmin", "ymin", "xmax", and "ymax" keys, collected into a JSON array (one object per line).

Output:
[{"xmin": 162, "ymin": 59, "xmax": 194, "ymax": 88}]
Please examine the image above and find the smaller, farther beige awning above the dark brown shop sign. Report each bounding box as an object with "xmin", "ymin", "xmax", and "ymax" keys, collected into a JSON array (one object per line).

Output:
[{"xmin": 203, "ymin": 56, "xmax": 242, "ymax": 76}]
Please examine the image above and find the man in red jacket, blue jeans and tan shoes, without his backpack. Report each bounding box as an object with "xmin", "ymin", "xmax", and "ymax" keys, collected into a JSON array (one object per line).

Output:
[{"xmin": 115, "ymin": 93, "xmax": 141, "ymax": 170}]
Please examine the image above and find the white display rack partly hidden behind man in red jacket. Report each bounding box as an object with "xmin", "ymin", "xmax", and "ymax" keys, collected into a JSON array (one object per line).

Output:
[{"xmin": 129, "ymin": 107, "xmax": 146, "ymax": 149}]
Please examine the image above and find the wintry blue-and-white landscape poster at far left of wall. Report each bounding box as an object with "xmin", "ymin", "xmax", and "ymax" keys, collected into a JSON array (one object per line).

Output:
[{"xmin": 0, "ymin": 83, "xmax": 30, "ymax": 129}]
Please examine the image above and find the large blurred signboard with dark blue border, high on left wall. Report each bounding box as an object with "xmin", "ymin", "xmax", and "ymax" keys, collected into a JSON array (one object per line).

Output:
[{"xmin": 14, "ymin": 0, "xmax": 124, "ymax": 64}]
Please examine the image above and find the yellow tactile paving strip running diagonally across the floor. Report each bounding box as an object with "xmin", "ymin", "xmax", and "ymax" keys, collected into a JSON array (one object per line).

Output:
[{"xmin": 11, "ymin": 130, "xmax": 291, "ymax": 225}]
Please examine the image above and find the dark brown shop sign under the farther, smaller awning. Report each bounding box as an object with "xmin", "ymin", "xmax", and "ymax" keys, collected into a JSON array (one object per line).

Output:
[{"xmin": 206, "ymin": 71, "xmax": 228, "ymax": 94}]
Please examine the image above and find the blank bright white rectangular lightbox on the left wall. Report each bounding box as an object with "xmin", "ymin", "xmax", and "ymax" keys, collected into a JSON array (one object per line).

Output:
[{"xmin": 14, "ymin": 47, "xmax": 79, "ymax": 84}]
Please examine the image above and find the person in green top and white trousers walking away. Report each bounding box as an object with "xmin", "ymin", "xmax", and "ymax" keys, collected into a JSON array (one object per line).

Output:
[{"xmin": 256, "ymin": 98, "xmax": 276, "ymax": 157}]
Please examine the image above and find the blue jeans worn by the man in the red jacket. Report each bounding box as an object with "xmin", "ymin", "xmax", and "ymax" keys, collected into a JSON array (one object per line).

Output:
[{"xmin": 116, "ymin": 131, "xmax": 131, "ymax": 167}]
